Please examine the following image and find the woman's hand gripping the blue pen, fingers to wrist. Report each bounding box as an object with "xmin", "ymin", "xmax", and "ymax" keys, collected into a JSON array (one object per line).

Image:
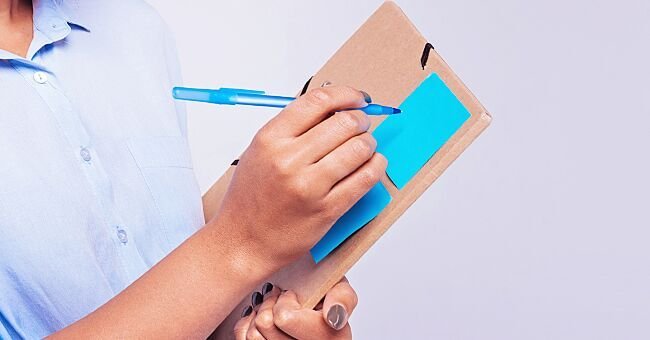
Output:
[{"xmin": 216, "ymin": 86, "xmax": 387, "ymax": 270}]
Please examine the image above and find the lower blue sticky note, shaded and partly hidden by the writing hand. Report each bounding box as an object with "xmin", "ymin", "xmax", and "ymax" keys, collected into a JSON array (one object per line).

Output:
[{"xmin": 311, "ymin": 183, "xmax": 391, "ymax": 263}]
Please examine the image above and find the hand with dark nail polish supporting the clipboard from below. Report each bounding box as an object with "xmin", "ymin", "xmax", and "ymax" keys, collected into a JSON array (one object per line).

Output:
[{"xmin": 235, "ymin": 278, "xmax": 357, "ymax": 340}]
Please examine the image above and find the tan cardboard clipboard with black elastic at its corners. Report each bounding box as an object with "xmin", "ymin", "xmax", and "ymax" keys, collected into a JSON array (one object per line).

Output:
[{"xmin": 204, "ymin": 2, "xmax": 491, "ymax": 308}]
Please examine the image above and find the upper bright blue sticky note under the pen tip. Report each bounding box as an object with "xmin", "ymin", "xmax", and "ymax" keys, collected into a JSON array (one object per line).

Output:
[{"xmin": 373, "ymin": 73, "xmax": 470, "ymax": 189}]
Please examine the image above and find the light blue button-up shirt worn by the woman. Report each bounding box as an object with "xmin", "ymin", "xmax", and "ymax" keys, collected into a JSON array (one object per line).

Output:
[{"xmin": 0, "ymin": 0, "xmax": 203, "ymax": 339}]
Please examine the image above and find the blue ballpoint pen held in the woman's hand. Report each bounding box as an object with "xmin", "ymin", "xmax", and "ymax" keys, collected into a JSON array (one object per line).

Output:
[{"xmin": 172, "ymin": 87, "xmax": 402, "ymax": 116}]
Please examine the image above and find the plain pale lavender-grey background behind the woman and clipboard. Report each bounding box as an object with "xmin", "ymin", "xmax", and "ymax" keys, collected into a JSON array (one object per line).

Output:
[{"xmin": 149, "ymin": 0, "xmax": 650, "ymax": 339}]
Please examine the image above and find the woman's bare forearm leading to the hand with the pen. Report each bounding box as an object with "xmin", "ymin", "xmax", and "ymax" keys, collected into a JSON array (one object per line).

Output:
[{"xmin": 51, "ymin": 221, "xmax": 274, "ymax": 339}]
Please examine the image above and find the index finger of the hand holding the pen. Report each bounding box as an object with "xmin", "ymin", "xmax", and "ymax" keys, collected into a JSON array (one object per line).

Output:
[{"xmin": 267, "ymin": 86, "xmax": 368, "ymax": 137}]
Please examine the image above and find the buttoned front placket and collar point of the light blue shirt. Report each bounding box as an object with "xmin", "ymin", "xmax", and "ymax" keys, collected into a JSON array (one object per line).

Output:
[{"xmin": 8, "ymin": 9, "xmax": 147, "ymax": 282}]
